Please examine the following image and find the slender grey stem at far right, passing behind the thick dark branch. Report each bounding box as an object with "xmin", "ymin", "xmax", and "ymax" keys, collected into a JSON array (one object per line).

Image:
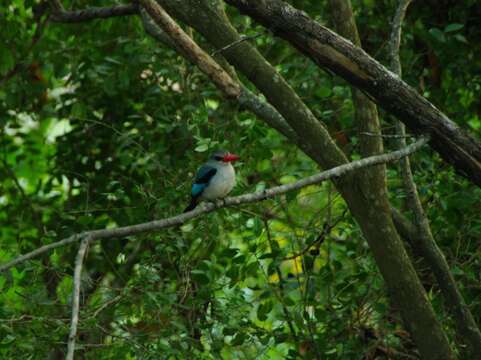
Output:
[{"xmin": 388, "ymin": 0, "xmax": 481, "ymax": 359}]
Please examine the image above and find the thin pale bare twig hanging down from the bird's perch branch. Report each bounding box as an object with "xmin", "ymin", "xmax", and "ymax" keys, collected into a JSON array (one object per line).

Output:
[{"xmin": 65, "ymin": 236, "xmax": 91, "ymax": 360}]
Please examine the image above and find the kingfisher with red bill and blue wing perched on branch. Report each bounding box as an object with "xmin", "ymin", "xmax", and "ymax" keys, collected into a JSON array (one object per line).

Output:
[{"xmin": 184, "ymin": 150, "xmax": 240, "ymax": 212}]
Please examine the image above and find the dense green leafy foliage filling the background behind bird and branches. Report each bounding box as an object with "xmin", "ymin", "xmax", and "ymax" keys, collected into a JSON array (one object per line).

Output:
[{"xmin": 0, "ymin": 0, "xmax": 481, "ymax": 359}]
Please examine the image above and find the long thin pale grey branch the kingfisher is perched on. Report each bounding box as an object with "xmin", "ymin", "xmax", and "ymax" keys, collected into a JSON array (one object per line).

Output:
[{"xmin": 0, "ymin": 138, "xmax": 428, "ymax": 272}]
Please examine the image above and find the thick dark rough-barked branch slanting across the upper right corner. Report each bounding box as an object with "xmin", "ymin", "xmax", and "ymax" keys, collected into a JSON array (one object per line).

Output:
[{"xmin": 226, "ymin": 0, "xmax": 481, "ymax": 186}]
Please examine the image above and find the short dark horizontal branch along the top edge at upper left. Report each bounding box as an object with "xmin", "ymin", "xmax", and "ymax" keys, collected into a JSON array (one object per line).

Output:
[{"xmin": 51, "ymin": 0, "xmax": 139, "ymax": 23}]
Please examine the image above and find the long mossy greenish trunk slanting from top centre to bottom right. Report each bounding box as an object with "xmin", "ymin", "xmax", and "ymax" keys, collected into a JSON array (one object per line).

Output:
[{"xmin": 153, "ymin": 0, "xmax": 452, "ymax": 359}]
